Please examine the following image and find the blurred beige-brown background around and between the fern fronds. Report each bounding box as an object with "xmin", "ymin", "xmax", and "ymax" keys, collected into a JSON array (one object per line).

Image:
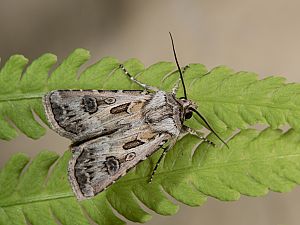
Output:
[{"xmin": 0, "ymin": 0, "xmax": 300, "ymax": 225}]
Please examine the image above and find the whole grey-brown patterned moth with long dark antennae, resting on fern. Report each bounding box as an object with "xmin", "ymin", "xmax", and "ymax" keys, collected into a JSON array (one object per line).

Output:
[{"xmin": 43, "ymin": 33, "xmax": 226, "ymax": 200}]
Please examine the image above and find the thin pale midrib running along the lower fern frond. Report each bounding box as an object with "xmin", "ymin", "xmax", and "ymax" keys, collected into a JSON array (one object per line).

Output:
[{"xmin": 0, "ymin": 153, "xmax": 300, "ymax": 208}]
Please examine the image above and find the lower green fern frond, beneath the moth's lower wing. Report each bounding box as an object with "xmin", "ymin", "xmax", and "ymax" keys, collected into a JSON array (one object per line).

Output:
[{"xmin": 0, "ymin": 128, "xmax": 300, "ymax": 225}]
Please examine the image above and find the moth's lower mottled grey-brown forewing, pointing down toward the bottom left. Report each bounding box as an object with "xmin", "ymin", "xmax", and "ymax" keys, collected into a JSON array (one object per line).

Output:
[{"xmin": 68, "ymin": 125, "xmax": 170, "ymax": 200}]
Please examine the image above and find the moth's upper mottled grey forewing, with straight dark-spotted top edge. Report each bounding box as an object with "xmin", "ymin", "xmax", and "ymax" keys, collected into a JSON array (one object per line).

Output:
[{"xmin": 43, "ymin": 90, "xmax": 151, "ymax": 142}]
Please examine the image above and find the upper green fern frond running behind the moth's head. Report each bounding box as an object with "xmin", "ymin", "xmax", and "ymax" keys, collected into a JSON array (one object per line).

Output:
[{"xmin": 0, "ymin": 49, "xmax": 300, "ymax": 140}]
